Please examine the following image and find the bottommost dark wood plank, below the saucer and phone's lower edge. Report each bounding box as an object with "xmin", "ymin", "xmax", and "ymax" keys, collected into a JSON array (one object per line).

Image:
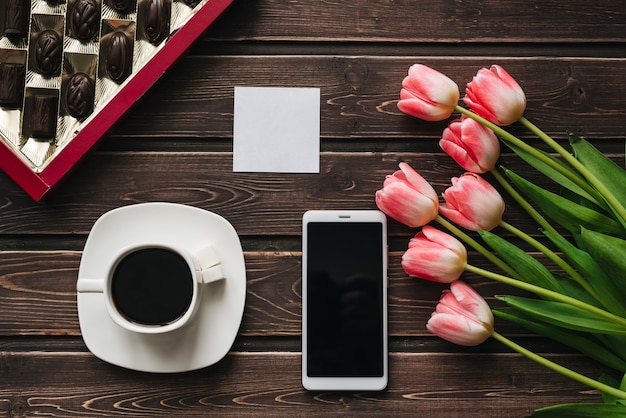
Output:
[{"xmin": 0, "ymin": 352, "xmax": 601, "ymax": 418}]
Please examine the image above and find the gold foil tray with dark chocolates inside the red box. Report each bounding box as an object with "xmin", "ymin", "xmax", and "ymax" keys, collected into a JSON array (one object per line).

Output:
[{"xmin": 0, "ymin": 0, "xmax": 205, "ymax": 172}]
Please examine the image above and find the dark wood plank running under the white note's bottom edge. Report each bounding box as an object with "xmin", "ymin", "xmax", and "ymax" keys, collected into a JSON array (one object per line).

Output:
[{"xmin": 0, "ymin": 152, "xmax": 623, "ymax": 238}]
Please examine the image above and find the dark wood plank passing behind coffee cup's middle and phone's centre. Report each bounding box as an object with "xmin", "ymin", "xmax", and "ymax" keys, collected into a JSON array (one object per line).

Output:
[{"xmin": 0, "ymin": 251, "xmax": 580, "ymax": 338}]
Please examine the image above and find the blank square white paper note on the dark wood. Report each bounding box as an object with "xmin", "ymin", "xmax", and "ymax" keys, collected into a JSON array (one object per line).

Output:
[{"xmin": 233, "ymin": 87, "xmax": 320, "ymax": 173}]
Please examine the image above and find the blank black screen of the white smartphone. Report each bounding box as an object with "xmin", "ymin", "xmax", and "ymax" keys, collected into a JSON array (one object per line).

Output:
[{"xmin": 306, "ymin": 222, "xmax": 386, "ymax": 377}]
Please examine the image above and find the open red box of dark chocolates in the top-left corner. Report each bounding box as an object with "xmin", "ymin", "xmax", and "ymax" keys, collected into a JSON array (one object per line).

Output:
[{"xmin": 0, "ymin": 0, "xmax": 233, "ymax": 201}]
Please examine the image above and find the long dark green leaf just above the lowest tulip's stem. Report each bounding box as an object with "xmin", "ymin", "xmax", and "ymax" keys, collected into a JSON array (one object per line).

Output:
[{"xmin": 492, "ymin": 308, "xmax": 626, "ymax": 372}]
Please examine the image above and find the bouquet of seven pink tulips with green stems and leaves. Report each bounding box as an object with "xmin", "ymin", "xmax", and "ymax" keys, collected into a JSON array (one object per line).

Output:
[{"xmin": 376, "ymin": 64, "xmax": 626, "ymax": 417}]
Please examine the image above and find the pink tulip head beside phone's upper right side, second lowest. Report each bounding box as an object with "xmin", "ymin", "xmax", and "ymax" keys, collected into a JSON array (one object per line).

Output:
[{"xmin": 401, "ymin": 225, "xmax": 467, "ymax": 283}]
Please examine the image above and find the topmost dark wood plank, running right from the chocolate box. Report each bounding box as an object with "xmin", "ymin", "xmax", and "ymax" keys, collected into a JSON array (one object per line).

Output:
[{"xmin": 210, "ymin": 0, "xmax": 626, "ymax": 43}]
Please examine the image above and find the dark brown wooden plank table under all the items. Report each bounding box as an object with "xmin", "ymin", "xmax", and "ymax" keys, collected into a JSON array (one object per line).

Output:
[{"xmin": 0, "ymin": 0, "xmax": 626, "ymax": 417}]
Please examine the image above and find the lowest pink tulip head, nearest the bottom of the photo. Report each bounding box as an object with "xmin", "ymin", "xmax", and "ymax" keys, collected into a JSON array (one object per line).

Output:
[{"xmin": 426, "ymin": 280, "xmax": 493, "ymax": 346}]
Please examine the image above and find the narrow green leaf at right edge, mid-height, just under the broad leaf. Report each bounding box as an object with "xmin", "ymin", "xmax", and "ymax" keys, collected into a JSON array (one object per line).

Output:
[{"xmin": 543, "ymin": 231, "xmax": 626, "ymax": 317}]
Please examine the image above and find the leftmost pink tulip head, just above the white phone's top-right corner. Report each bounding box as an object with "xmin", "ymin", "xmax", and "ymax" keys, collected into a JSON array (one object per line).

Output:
[{"xmin": 376, "ymin": 163, "xmax": 439, "ymax": 228}]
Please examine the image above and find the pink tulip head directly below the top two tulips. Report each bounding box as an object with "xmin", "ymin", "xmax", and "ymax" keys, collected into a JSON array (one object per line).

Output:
[{"xmin": 439, "ymin": 116, "xmax": 500, "ymax": 173}]
